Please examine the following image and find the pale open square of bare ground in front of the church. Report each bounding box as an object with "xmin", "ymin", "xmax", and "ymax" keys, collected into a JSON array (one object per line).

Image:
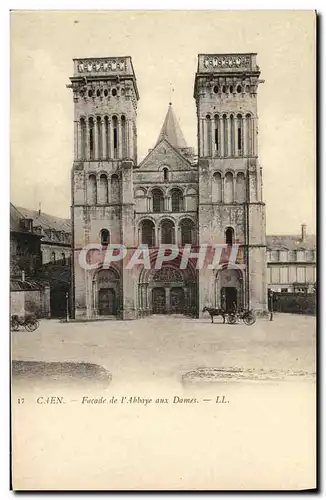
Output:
[{"xmin": 12, "ymin": 314, "xmax": 316, "ymax": 380}]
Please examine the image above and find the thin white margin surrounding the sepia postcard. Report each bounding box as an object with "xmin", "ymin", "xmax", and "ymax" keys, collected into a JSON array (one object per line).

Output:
[{"xmin": 0, "ymin": 0, "xmax": 326, "ymax": 499}]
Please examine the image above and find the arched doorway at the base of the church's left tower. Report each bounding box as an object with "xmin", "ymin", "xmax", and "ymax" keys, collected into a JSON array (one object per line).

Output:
[{"xmin": 93, "ymin": 268, "xmax": 120, "ymax": 317}]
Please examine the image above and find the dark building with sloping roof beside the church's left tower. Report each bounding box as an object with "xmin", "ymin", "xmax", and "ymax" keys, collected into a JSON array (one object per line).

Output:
[{"xmin": 10, "ymin": 203, "xmax": 71, "ymax": 317}]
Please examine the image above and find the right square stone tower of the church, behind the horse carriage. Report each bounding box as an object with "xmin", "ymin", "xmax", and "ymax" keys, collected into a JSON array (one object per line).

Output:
[{"xmin": 194, "ymin": 54, "xmax": 267, "ymax": 311}]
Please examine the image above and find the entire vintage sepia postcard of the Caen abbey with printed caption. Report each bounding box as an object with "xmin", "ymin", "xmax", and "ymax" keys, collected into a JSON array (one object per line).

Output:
[{"xmin": 10, "ymin": 10, "xmax": 317, "ymax": 491}]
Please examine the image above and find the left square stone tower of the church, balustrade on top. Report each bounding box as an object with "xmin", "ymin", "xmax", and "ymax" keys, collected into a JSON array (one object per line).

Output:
[{"xmin": 68, "ymin": 57, "xmax": 139, "ymax": 319}]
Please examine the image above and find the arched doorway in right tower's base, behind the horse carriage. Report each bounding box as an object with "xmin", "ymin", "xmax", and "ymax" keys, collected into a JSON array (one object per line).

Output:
[{"xmin": 215, "ymin": 267, "xmax": 244, "ymax": 312}]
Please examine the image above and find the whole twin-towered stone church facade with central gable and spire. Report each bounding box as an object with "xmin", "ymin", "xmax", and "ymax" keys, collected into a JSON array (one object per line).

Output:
[{"xmin": 68, "ymin": 54, "xmax": 267, "ymax": 319}]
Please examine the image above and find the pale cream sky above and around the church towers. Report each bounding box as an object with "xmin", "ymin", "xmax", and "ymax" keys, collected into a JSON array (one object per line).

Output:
[{"xmin": 11, "ymin": 11, "xmax": 316, "ymax": 234}]
